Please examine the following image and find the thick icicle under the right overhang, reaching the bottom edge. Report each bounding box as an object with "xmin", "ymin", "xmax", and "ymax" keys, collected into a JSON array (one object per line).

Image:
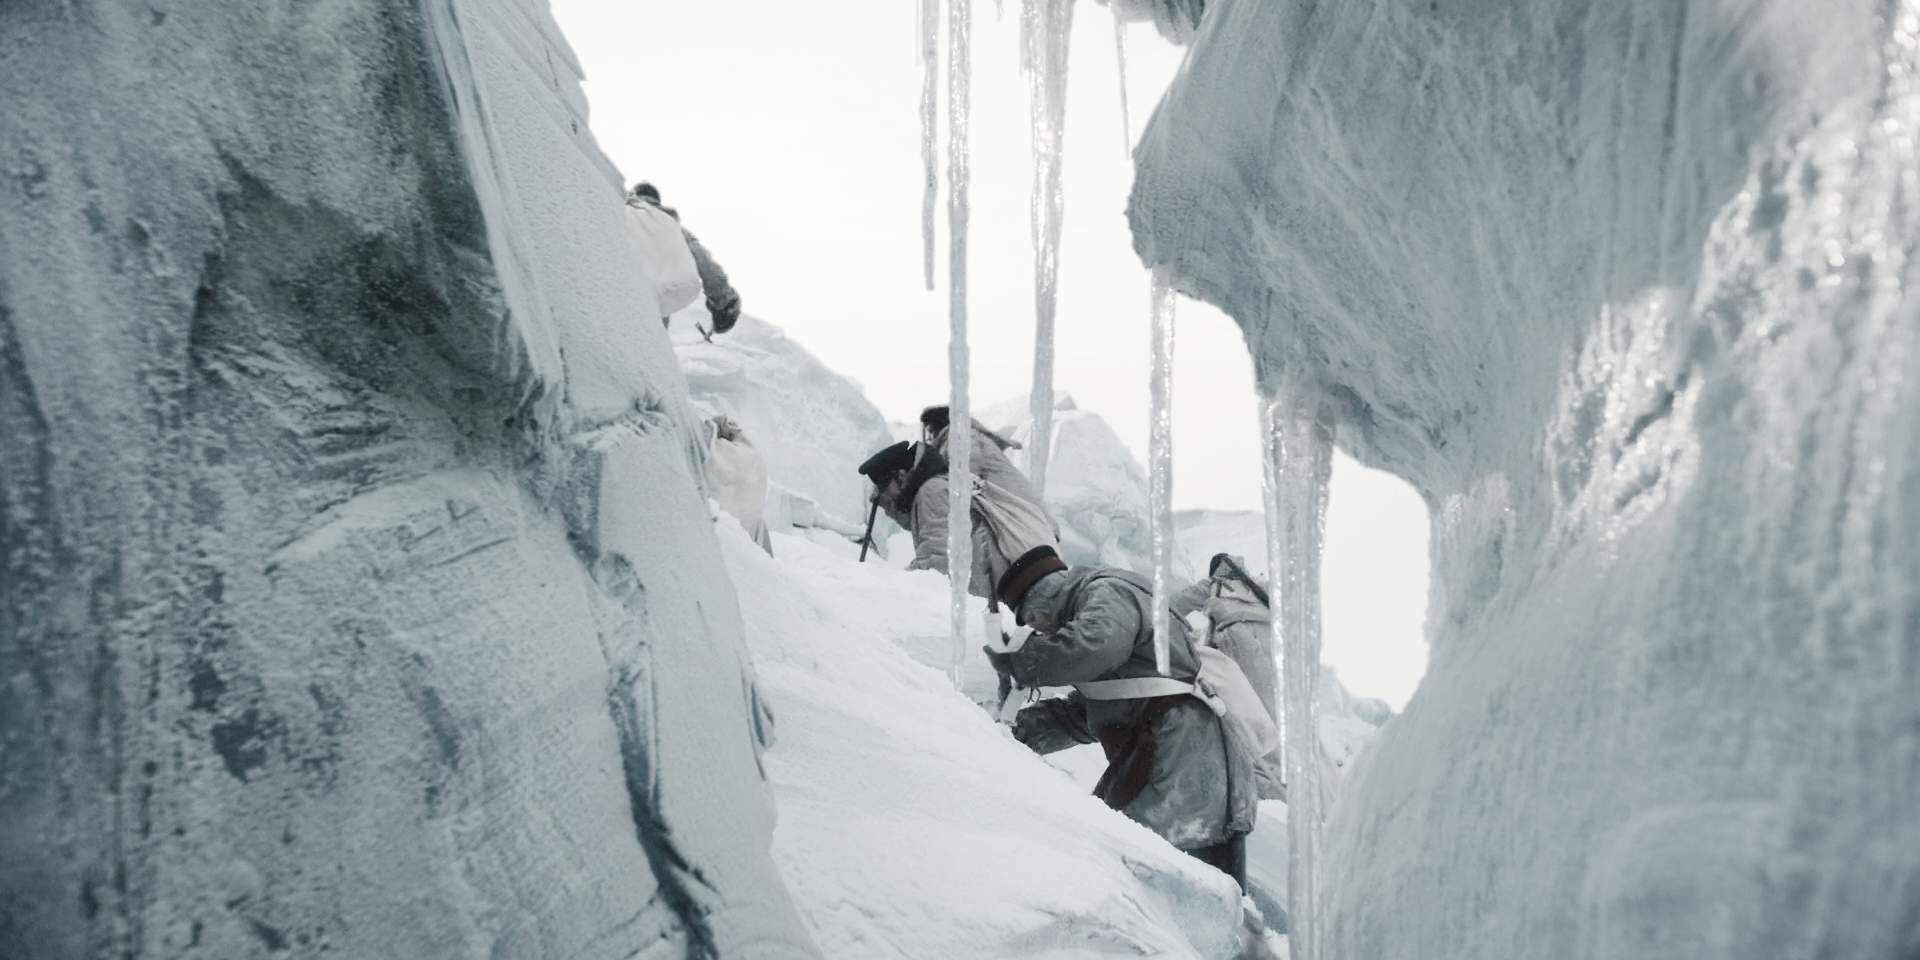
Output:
[{"xmin": 1261, "ymin": 376, "xmax": 1332, "ymax": 960}]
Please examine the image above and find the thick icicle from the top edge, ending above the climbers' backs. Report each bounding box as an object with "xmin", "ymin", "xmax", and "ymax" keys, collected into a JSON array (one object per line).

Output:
[{"xmin": 1020, "ymin": 0, "xmax": 1073, "ymax": 503}]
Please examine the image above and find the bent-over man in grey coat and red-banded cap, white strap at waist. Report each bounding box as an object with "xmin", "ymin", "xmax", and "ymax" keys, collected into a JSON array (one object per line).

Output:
[{"xmin": 987, "ymin": 547, "xmax": 1258, "ymax": 889}]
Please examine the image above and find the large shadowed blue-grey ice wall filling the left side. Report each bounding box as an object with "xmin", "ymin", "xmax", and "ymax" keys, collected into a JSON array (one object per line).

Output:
[{"xmin": 0, "ymin": 0, "xmax": 816, "ymax": 958}]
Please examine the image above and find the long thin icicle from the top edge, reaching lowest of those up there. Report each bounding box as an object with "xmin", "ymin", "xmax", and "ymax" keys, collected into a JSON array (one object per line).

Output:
[{"xmin": 947, "ymin": 0, "xmax": 973, "ymax": 689}]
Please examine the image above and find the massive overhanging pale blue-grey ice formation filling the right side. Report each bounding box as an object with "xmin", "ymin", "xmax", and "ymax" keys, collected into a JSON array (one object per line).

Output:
[{"xmin": 1133, "ymin": 0, "xmax": 1920, "ymax": 958}]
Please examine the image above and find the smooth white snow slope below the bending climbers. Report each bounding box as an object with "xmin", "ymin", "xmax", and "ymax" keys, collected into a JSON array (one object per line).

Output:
[{"xmin": 718, "ymin": 526, "xmax": 1240, "ymax": 960}]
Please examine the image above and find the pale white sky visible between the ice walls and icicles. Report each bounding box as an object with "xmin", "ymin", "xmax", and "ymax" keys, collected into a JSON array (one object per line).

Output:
[{"xmin": 553, "ymin": 0, "xmax": 1427, "ymax": 708}]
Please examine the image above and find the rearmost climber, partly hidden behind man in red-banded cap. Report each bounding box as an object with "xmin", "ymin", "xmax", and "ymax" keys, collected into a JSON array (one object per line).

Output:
[{"xmin": 1169, "ymin": 553, "xmax": 1286, "ymax": 801}]
